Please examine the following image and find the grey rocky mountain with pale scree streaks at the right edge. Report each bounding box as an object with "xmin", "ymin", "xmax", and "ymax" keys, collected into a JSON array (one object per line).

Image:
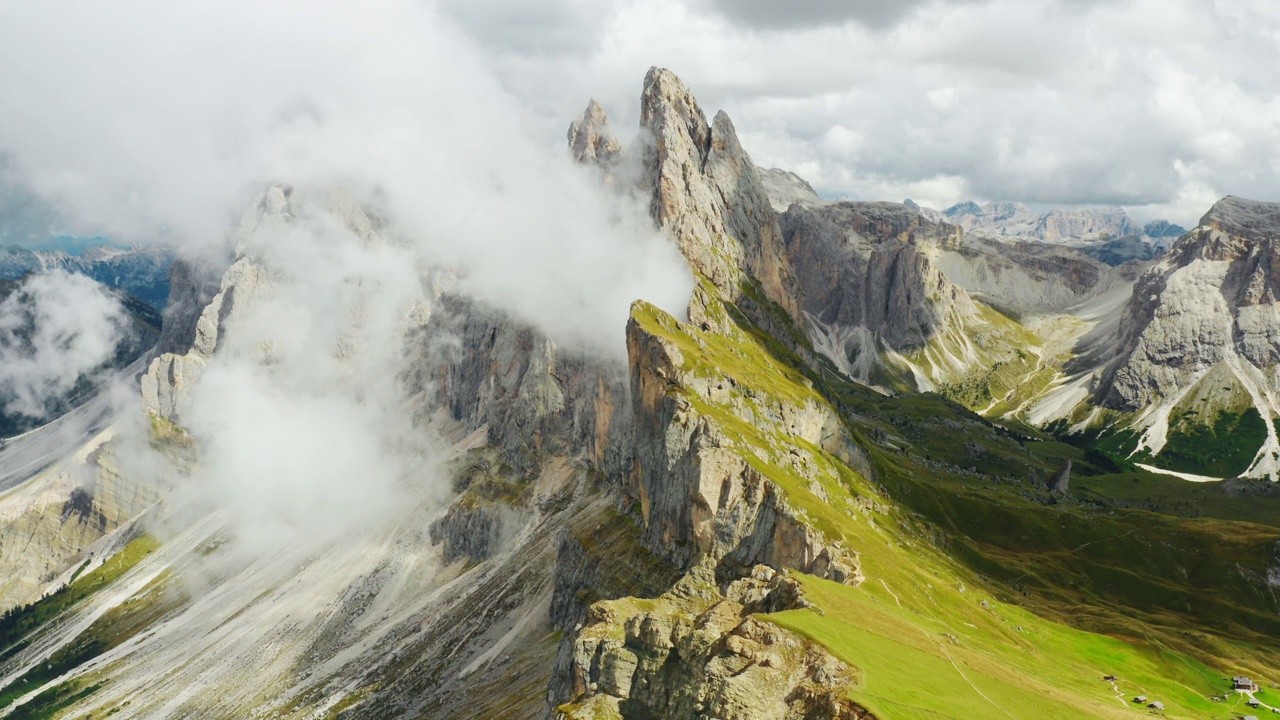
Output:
[{"xmin": 1097, "ymin": 197, "xmax": 1280, "ymax": 475}]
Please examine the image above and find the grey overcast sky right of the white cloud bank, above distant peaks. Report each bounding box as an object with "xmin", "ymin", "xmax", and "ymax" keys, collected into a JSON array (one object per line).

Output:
[{"xmin": 445, "ymin": 0, "xmax": 1280, "ymax": 224}]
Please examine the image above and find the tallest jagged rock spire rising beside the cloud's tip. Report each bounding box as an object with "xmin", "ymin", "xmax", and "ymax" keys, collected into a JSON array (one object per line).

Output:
[{"xmin": 640, "ymin": 68, "xmax": 800, "ymax": 333}]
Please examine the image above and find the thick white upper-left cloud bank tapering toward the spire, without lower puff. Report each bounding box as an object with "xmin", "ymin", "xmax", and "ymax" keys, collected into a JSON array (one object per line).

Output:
[{"xmin": 0, "ymin": 0, "xmax": 691, "ymax": 351}]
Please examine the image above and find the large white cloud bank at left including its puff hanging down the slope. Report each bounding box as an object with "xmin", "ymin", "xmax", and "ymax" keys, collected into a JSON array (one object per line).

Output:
[{"xmin": 0, "ymin": 0, "xmax": 692, "ymax": 550}]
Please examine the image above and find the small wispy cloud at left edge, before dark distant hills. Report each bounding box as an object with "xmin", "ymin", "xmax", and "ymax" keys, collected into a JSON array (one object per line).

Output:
[{"xmin": 0, "ymin": 270, "xmax": 128, "ymax": 418}]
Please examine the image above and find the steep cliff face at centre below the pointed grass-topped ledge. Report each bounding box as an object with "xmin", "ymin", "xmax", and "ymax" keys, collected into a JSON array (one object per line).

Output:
[{"xmin": 626, "ymin": 307, "xmax": 861, "ymax": 583}]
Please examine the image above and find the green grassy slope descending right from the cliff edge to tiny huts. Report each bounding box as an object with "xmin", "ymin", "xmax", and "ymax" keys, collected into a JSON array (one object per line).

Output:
[{"xmin": 643, "ymin": 288, "xmax": 1280, "ymax": 719}]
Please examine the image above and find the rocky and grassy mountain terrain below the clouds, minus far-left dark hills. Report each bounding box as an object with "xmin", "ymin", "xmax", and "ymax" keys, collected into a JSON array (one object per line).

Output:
[{"xmin": 0, "ymin": 68, "xmax": 1280, "ymax": 720}]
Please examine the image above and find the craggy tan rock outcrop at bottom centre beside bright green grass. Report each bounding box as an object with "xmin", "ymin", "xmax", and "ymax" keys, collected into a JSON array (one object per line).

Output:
[{"xmin": 557, "ymin": 565, "xmax": 872, "ymax": 720}]
